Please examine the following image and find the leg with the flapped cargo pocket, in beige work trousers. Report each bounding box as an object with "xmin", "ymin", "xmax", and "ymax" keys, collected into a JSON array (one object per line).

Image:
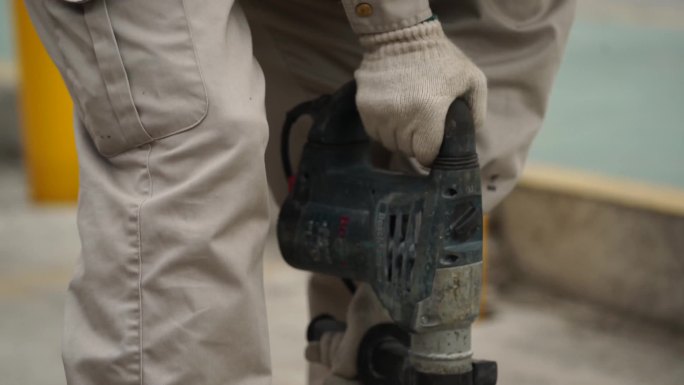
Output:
[{"xmin": 27, "ymin": 0, "xmax": 270, "ymax": 385}]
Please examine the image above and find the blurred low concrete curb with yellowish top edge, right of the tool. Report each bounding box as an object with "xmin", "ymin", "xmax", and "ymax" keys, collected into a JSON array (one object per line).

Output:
[{"xmin": 492, "ymin": 164, "xmax": 684, "ymax": 330}]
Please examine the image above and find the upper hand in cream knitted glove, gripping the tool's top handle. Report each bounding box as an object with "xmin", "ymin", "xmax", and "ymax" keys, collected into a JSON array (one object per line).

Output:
[{"xmin": 354, "ymin": 20, "xmax": 487, "ymax": 166}]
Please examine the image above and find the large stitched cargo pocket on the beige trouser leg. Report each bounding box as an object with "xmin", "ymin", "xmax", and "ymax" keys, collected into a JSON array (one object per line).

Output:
[{"xmin": 47, "ymin": 0, "xmax": 209, "ymax": 157}]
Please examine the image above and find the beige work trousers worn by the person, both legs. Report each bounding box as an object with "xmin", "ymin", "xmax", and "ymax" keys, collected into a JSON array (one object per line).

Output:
[{"xmin": 26, "ymin": 0, "xmax": 574, "ymax": 385}]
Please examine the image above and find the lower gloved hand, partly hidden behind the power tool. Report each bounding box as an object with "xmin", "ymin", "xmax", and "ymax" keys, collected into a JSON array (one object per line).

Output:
[{"xmin": 305, "ymin": 283, "xmax": 391, "ymax": 385}]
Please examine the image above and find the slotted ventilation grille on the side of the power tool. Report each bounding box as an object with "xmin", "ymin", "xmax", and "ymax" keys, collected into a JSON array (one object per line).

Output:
[{"xmin": 384, "ymin": 209, "xmax": 422, "ymax": 292}]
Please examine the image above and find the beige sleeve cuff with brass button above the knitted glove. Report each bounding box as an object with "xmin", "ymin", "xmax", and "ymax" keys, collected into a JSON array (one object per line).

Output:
[{"xmin": 342, "ymin": 0, "xmax": 432, "ymax": 34}]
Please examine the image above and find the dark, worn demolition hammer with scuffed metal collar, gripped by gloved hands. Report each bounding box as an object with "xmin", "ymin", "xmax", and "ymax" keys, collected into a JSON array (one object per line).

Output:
[{"xmin": 277, "ymin": 82, "xmax": 497, "ymax": 385}]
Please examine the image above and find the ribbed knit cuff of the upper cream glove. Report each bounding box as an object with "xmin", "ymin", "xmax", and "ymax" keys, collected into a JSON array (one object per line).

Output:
[{"xmin": 360, "ymin": 20, "xmax": 449, "ymax": 60}]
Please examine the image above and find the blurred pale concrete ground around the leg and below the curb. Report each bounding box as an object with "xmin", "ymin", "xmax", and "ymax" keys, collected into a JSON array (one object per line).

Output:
[{"xmin": 0, "ymin": 166, "xmax": 684, "ymax": 385}]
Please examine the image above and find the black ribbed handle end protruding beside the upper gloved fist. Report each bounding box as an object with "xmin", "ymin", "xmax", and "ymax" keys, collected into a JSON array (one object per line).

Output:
[{"xmin": 432, "ymin": 98, "xmax": 478, "ymax": 170}]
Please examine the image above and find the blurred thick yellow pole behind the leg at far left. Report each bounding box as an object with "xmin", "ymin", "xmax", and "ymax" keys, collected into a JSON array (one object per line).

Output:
[{"xmin": 14, "ymin": 0, "xmax": 78, "ymax": 202}]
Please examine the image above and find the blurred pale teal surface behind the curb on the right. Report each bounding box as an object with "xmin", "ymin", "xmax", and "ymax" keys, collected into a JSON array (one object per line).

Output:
[{"xmin": 529, "ymin": 20, "xmax": 684, "ymax": 188}]
